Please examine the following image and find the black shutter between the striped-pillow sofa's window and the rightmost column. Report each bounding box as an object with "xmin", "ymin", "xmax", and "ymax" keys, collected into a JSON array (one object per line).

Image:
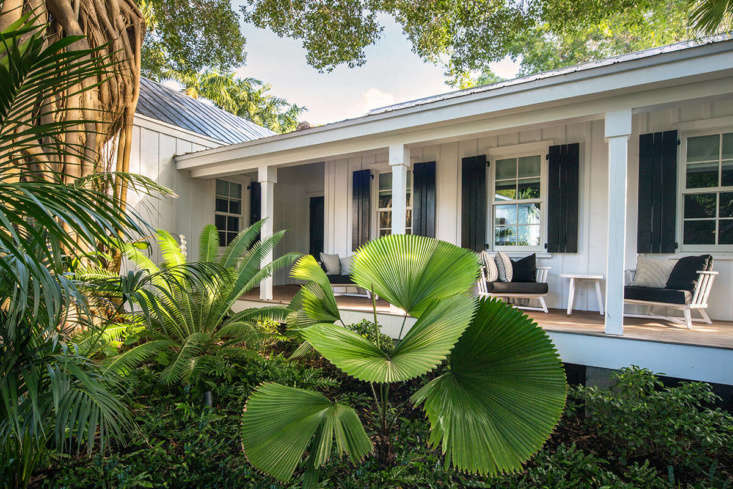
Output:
[{"xmin": 547, "ymin": 143, "xmax": 580, "ymax": 253}]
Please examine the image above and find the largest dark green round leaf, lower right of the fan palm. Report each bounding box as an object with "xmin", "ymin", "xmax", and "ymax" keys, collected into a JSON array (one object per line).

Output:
[{"xmin": 412, "ymin": 299, "xmax": 567, "ymax": 474}]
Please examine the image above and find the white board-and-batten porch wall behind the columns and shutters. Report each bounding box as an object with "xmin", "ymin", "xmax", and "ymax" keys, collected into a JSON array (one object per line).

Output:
[{"xmin": 324, "ymin": 98, "xmax": 733, "ymax": 320}]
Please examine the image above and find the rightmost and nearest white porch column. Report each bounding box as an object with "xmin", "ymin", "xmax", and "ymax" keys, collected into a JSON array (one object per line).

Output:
[{"xmin": 605, "ymin": 108, "xmax": 631, "ymax": 335}]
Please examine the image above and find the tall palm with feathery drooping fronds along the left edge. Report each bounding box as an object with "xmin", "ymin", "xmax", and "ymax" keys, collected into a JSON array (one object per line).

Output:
[{"xmin": 0, "ymin": 12, "xmax": 154, "ymax": 487}]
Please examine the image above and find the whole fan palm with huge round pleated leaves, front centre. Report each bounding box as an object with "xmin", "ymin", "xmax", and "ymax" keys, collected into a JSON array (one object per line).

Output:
[{"xmin": 242, "ymin": 235, "xmax": 566, "ymax": 484}]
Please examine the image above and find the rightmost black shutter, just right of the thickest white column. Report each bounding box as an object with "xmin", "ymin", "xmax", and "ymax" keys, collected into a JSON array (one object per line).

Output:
[{"xmin": 636, "ymin": 131, "xmax": 677, "ymax": 253}]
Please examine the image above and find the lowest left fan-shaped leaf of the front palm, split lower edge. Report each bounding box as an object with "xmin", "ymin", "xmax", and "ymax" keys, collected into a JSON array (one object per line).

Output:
[{"xmin": 242, "ymin": 383, "xmax": 372, "ymax": 482}]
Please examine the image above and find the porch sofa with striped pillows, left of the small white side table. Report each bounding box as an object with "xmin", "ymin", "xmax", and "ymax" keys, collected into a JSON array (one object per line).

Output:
[{"xmin": 476, "ymin": 251, "xmax": 550, "ymax": 313}]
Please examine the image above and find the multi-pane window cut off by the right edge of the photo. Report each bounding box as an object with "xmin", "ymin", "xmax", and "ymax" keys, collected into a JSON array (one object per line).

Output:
[{"xmin": 682, "ymin": 133, "xmax": 733, "ymax": 245}]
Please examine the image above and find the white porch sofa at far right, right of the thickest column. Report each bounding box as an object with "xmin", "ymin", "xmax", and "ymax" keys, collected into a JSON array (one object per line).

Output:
[{"xmin": 624, "ymin": 255, "xmax": 718, "ymax": 329}]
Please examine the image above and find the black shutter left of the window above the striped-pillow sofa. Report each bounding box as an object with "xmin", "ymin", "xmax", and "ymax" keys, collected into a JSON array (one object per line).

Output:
[{"xmin": 461, "ymin": 155, "xmax": 488, "ymax": 251}]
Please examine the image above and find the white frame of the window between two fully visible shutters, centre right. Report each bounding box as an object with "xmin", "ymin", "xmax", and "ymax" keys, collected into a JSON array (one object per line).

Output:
[{"xmin": 486, "ymin": 141, "xmax": 552, "ymax": 252}]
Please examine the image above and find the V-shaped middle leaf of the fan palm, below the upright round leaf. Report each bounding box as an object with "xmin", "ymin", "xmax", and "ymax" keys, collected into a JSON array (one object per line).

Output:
[{"xmin": 301, "ymin": 295, "xmax": 474, "ymax": 383}]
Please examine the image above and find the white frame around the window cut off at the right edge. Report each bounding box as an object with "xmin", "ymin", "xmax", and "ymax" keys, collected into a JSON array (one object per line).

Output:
[{"xmin": 676, "ymin": 126, "xmax": 733, "ymax": 253}]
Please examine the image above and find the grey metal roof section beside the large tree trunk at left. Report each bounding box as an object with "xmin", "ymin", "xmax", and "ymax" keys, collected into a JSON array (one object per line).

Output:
[{"xmin": 135, "ymin": 77, "xmax": 275, "ymax": 144}]
